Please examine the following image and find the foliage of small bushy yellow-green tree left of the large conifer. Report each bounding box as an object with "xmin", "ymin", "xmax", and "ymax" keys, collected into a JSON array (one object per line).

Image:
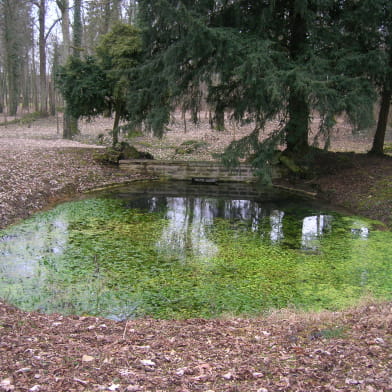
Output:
[{"xmin": 57, "ymin": 24, "xmax": 141, "ymax": 142}]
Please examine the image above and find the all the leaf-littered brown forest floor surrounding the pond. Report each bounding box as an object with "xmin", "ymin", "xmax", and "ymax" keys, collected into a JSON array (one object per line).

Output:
[{"xmin": 0, "ymin": 114, "xmax": 392, "ymax": 392}]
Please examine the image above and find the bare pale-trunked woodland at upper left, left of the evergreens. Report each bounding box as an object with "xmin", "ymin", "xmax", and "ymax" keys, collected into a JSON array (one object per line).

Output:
[{"xmin": 0, "ymin": 0, "xmax": 137, "ymax": 130}]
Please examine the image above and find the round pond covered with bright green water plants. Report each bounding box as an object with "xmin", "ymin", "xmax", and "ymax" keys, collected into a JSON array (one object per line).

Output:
[{"xmin": 0, "ymin": 182, "xmax": 392, "ymax": 320}]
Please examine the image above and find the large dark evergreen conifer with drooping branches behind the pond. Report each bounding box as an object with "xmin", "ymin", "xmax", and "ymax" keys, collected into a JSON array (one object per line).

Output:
[{"xmin": 129, "ymin": 0, "xmax": 374, "ymax": 171}]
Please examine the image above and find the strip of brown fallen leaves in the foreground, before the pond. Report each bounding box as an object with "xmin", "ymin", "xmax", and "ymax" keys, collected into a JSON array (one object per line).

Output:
[{"xmin": 0, "ymin": 304, "xmax": 392, "ymax": 392}]
